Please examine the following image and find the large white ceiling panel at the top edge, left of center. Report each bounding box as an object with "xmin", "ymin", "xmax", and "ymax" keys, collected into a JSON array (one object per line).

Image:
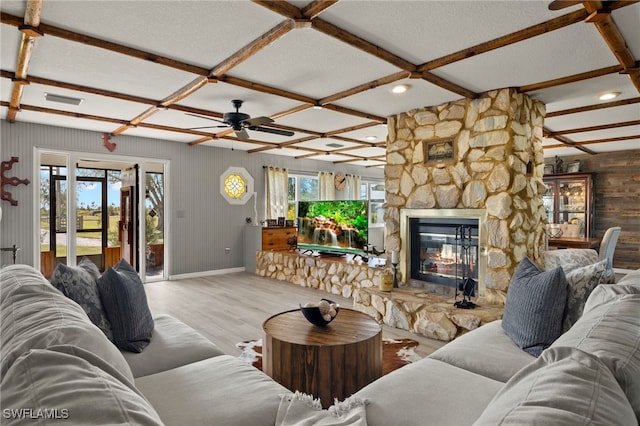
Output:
[{"xmin": 33, "ymin": 0, "xmax": 283, "ymax": 68}]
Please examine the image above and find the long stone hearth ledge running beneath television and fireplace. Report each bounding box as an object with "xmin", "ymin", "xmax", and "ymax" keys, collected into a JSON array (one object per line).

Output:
[{"xmin": 256, "ymin": 251, "xmax": 504, "ymax": 341}]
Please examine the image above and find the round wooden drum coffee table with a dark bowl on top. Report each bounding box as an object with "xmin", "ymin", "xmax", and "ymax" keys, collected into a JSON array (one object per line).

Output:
[{"xmin": 262, "ymin": 308, "xmax": 382, "ymax": 408}]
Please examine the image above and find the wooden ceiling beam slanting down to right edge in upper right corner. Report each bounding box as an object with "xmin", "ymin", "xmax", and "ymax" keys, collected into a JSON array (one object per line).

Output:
[{"xmin": 583, "ymin": 2, "xmax": 640, "ymax": 92}]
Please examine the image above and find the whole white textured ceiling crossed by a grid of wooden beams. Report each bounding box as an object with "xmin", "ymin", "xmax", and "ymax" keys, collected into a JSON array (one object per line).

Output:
[{"xmin": 0, "ymin": 0, "xmax": 640, "ymax": 166}]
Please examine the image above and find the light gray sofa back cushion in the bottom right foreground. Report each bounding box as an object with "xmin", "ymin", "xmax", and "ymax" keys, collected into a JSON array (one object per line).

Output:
[{"xmin": 474, "ymin": 346, "xmax": 637, "ymax": 426}]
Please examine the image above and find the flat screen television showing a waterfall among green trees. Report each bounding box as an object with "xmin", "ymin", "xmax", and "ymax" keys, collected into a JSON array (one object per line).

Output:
[{"xmin": 298, "ymin": 200, "xmax": 369, "ymax": 254}]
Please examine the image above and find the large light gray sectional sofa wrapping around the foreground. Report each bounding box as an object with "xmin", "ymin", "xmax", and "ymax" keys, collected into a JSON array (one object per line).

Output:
[{"xmin": 0, "ymin": 265, "xmax": 640, "ymax": 426}]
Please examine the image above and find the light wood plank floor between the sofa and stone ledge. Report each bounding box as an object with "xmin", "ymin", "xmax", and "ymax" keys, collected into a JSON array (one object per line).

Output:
[{"xmin": 145, "ymin": 272, "xmax": 444, "ymax": 357}]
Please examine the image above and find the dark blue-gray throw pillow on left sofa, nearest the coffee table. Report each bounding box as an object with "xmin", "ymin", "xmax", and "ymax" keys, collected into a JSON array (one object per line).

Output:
[{"xmin": 98, "ymin": 259, "xmax": 154, "ymax": 352}]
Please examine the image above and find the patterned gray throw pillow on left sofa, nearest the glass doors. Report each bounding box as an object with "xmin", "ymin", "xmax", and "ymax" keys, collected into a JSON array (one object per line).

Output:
[{"xmin": 51, "ymin": 257, "xmax": 113, "ymax": 340}]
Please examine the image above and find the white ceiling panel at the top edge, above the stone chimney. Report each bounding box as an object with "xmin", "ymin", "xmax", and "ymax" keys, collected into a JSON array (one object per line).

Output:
[{"xmin": 322, "ymin": 1, "xmax": 559, "ymax": 65}]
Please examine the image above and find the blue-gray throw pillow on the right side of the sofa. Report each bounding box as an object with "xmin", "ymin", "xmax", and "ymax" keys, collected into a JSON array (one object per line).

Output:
[{"xmin": 502, "ymin": 257, "xmax": 567, "ymax": 356}]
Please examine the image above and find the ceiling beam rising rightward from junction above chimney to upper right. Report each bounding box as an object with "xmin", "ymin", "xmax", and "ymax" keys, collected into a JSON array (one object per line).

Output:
[{"xmin": 417, "ymin": 9, "xmax": 587, "ymax": 72}]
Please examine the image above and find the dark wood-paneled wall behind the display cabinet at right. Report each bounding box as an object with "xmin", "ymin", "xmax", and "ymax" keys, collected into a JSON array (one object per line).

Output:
[{"xmin": 547, "ymin": 149, "xmax": 640, "ymax": 269}]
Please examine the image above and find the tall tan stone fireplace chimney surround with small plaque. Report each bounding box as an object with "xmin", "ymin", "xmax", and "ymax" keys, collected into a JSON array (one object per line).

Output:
[{"xmin": 385, "ymin": 88, "xmax": 546, "ymax": 304}]
